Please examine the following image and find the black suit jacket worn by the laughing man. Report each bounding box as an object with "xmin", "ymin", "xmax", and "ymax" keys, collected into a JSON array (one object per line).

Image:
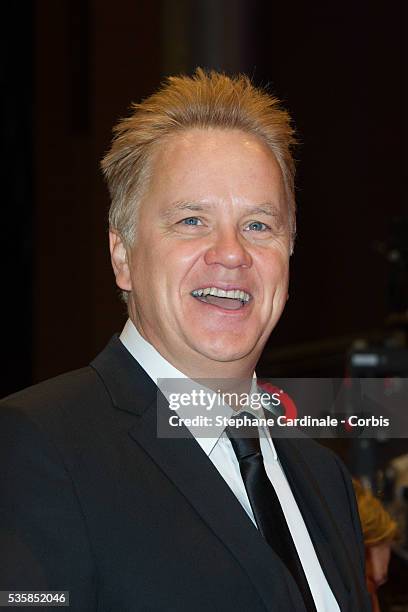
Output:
[{"xmin": 0, "ymin": 337, "xmax": 370, "ymax": 612}]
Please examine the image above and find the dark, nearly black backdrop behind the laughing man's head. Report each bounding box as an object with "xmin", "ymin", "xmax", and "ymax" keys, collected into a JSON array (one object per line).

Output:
[{"xmin": 0, "ymin": 0, "xmax": 408, "ymax": 604}]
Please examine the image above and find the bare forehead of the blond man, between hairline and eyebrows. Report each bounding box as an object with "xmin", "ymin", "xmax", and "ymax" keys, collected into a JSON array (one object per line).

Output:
[{"xmin": 148, "ymin": 129, "xmax": 284, "ymax": 209}]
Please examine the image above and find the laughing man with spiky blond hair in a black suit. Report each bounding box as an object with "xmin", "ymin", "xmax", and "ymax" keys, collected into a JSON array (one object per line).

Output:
[{"xmin": 0, "ymin": 70, "xmax": 369, "ymax": 612}]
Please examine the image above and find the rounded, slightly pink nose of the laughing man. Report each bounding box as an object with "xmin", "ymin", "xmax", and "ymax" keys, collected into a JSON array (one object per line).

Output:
[{"xmin": 204, "ymin": 227, "xmax": 252, "ymax": 269}]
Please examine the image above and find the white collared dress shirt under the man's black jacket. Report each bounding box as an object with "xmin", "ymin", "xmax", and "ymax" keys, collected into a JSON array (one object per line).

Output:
[{"xmin": 120, "ymin": 319, "xmax": 340, "ymax": 612}]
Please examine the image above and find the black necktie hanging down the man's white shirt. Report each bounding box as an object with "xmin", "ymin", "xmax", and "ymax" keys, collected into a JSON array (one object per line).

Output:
[{"xmin": 226, "ymin": 413, "xmax": 316, "ymax": 612}]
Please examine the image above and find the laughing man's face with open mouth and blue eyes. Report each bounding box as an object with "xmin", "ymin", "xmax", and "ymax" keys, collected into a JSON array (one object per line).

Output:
[{"xmin": 110, "ymin": 129, "xmax": 290, "ymax": 373}]
